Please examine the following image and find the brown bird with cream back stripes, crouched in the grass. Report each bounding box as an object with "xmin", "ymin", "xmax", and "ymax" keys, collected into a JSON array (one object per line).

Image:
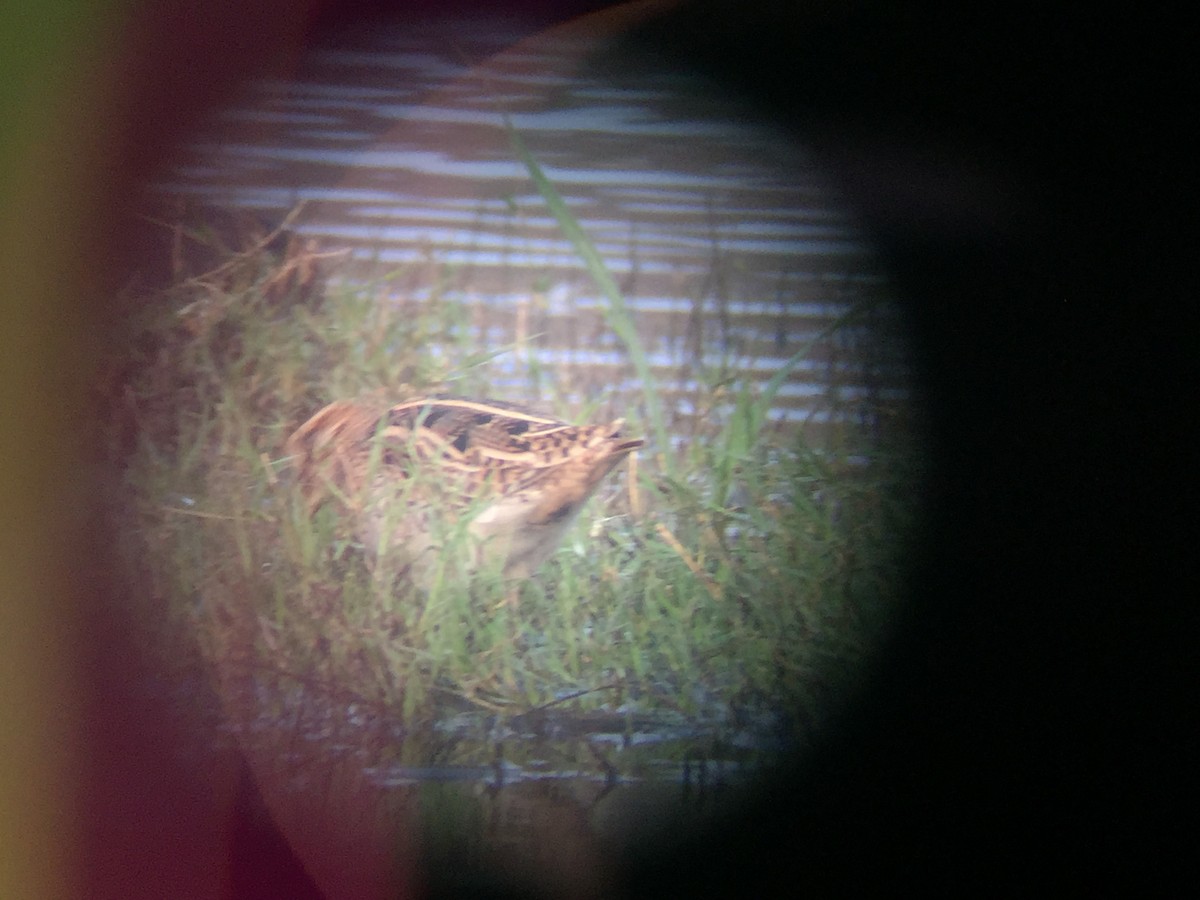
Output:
[{"xmin": 286, "ymin": 395, "xmax": 646, "ymax": 590}]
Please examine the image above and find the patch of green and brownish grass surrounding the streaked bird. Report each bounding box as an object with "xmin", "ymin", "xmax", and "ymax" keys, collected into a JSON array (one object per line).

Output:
[{"xmin": 112, "ymin": 196, "xmax": 910, "ymax": 753}]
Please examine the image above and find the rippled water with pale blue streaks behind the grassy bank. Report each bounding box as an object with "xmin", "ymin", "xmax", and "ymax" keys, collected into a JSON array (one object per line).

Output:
[{"xmin": 160, "ymin": 15, "xmax": 908, "ymax": 434}]
